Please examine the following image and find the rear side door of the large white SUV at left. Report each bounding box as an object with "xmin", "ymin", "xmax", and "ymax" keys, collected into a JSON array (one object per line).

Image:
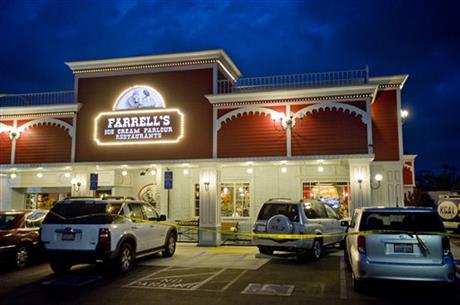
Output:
[{"xmin": 128, "ymin": 202, "xmax": 152, "ymax": 252}]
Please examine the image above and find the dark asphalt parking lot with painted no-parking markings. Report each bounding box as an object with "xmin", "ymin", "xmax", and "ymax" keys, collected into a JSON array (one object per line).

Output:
[{"xmin": 0, "ymin": 241, "xmax": 460, "ymax": 305}]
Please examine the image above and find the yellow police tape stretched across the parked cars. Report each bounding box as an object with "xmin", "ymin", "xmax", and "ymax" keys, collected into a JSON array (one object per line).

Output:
[{"xmin": 45, "ymin": 211, "xmax": 460, "ymax": 240}]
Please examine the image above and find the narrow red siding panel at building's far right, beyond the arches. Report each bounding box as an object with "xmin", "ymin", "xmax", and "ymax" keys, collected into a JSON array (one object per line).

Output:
[{"xmin": 371, "ymin": 90, "xmax": 399, "ymax": 161}]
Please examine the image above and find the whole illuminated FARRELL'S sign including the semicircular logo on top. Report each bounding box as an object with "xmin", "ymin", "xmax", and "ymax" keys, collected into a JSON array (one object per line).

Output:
[{"xmin": 94, "ymin": 86, "xmax": 184, "ymax": 145}]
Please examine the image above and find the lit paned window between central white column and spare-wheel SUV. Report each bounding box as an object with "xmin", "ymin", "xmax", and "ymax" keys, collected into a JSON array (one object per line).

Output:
[{"xmin": 220, "ymin": 183, "xmax": 250, "ymax": 217}]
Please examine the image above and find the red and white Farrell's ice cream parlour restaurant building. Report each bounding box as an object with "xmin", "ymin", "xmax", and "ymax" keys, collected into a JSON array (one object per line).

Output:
[{"xmin": 0, "ymin": 50, "xmax": 416, "ymax": 244}]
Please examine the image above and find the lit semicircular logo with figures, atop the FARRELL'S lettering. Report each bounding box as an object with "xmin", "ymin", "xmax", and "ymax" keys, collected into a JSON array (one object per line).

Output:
[{"xmin": 114, "ymin": 86, "xmax": 165, "ymax": 110}]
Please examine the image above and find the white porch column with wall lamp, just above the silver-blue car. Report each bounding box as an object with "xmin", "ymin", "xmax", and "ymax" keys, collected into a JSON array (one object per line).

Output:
[{"xmin": 348, "ymin": 159, "xmax": 373, "ymax": 211}]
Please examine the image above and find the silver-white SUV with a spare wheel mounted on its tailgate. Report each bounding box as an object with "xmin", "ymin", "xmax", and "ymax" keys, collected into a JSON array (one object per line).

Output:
[{"xmin": 254, "ymin": 199, "xmax": 345, "ymax": 259}]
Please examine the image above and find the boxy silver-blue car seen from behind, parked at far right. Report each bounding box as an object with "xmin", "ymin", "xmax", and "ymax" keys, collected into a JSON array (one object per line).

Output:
[{"xmin": 345, "ymin": 207, "xmax": 455, "ymax": 291}]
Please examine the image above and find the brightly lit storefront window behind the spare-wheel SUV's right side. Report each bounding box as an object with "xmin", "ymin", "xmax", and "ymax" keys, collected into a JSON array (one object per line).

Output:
[{"xmin": 303, "ymin": 182, "xmax": 350, "ymax": 217}]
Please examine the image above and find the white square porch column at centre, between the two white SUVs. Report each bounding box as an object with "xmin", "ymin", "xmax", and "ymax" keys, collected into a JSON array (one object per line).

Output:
[{"xmin": 198, "ymin": 168, "xmax": 220, "ymax": 246}]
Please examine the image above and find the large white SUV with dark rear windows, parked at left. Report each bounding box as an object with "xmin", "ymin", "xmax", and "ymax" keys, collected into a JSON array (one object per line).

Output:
[{"xmin": 40, "ymin": 198, "xmax": 177, "ymax": 273}]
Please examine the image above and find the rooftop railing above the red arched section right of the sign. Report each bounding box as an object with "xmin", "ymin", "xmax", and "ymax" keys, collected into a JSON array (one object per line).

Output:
[{"xmin": 218, "ymin": 67, "xmax": 369, "ymax": 94}]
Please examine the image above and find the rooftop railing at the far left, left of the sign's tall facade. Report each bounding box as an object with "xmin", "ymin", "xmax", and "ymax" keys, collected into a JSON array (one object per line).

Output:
[{"xmin": 0, "ymin": 91, "xmax": 75, "ymax": 107}]
